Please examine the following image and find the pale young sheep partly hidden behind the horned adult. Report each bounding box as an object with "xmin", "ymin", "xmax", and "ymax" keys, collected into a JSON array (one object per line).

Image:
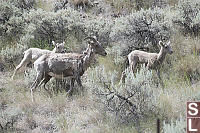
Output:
[{"xmin": 12, "ymin": 41, "xmax": 65, "ymax": 79}]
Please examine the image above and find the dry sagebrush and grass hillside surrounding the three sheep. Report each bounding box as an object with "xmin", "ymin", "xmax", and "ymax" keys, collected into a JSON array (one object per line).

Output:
[{"xmin": 0, "ymin": 0, "xmax": 200, "ymax": 133}]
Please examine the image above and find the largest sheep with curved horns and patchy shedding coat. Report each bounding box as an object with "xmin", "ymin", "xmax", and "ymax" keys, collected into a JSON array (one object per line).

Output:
[{"xmin": 31, "ymin": 37, "xmax": 107, "ymax": 100}]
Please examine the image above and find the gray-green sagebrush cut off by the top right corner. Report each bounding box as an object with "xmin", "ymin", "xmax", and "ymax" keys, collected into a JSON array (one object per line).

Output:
[{"xmin": 173, "ymin": 0, "xmax": 200, "ymax": 36}]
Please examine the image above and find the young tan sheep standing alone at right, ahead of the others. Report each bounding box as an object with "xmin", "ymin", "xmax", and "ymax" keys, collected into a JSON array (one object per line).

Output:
[{"xmin": 121, "ymin": 41, "xmax": 173, "ymax": 86}]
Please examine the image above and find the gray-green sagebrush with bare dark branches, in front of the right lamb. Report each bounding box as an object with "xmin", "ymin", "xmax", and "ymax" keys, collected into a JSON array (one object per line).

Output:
[{"xmin": 87, "ymin": 66, "xmax": 159, "ymax": 123}]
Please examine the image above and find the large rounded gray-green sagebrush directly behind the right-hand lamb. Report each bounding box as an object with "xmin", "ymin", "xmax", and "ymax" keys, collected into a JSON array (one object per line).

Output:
[{"xmin": 110, "ymin": 8, "xmax": 171, "ymax": 54}]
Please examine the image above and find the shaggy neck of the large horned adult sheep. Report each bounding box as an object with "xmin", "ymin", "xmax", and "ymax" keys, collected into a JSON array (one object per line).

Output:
[{"xmin": 83, "ymin": 48, "xmax": 95, "ymax": 71}]
